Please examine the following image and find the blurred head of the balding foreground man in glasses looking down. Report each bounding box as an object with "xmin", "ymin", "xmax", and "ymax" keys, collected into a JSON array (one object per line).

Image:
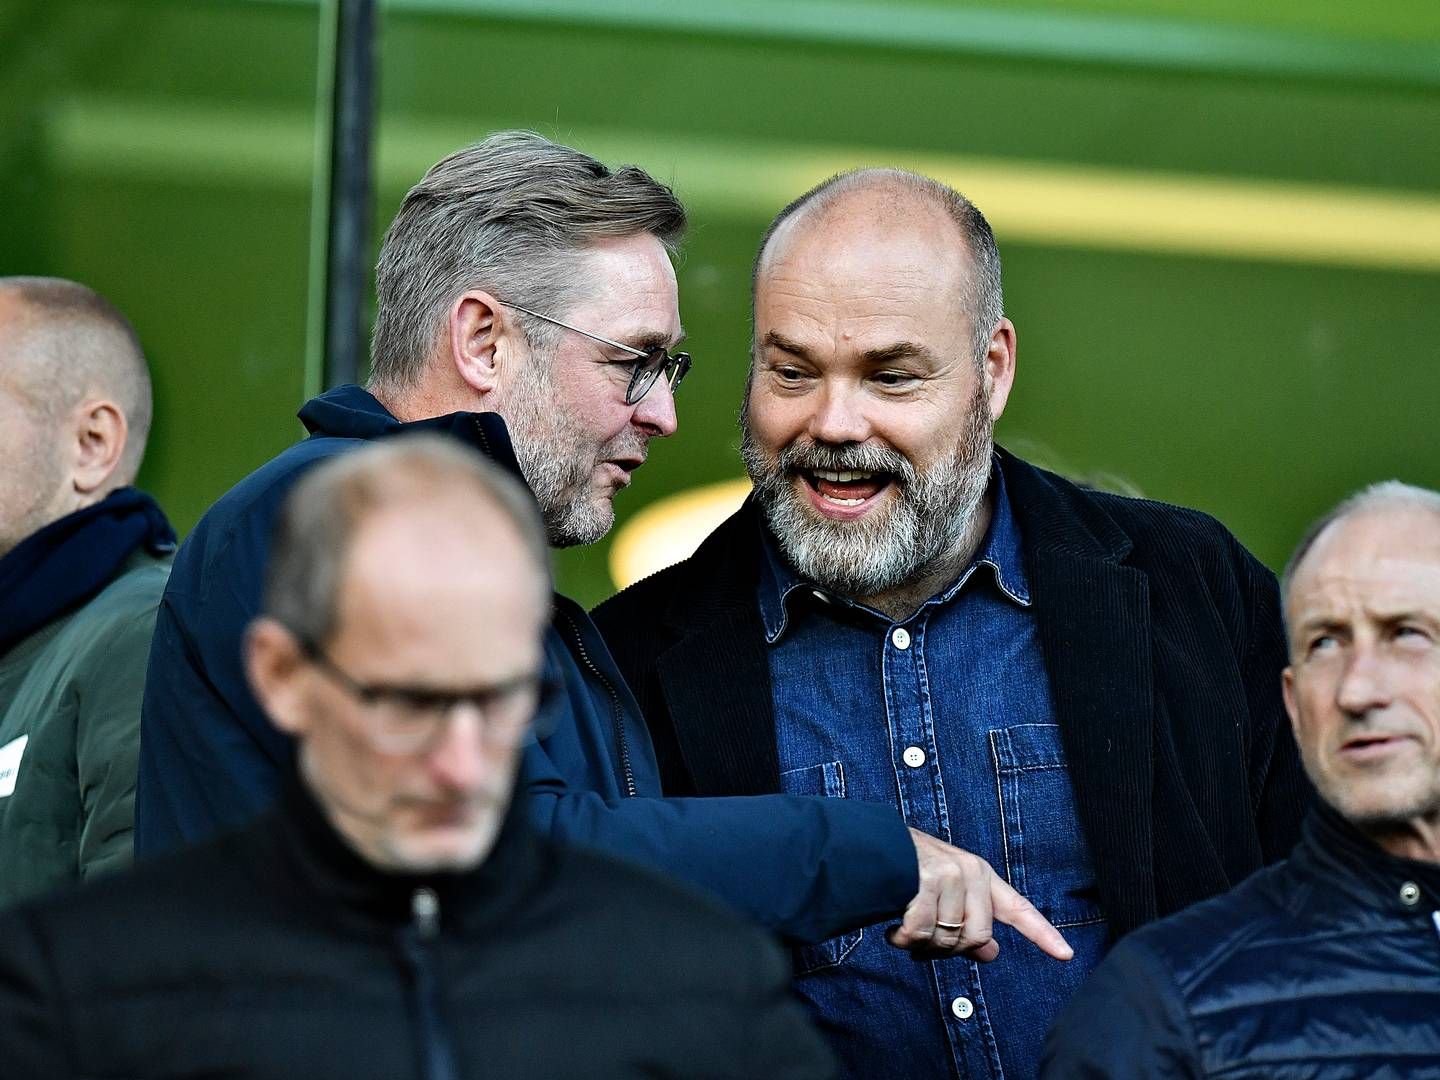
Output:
[{"xmin": 246, "ymin": 436, "xmax": 550, "ymax": 873}]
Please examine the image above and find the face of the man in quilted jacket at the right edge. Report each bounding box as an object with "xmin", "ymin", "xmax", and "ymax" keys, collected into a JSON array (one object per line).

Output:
[{"xmin": 1284, "ymin": 507, "xmax": 1440, "ymax": 852}]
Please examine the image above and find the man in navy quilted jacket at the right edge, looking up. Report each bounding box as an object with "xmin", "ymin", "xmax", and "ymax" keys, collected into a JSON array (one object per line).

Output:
[{"xmin": 1044, "ymin": 482, "xmax": 1440, "ymax": 1080}]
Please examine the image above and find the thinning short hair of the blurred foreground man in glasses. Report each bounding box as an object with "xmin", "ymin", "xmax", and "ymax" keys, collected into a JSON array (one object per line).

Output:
[{"xmin": 261, "ymin": 435, "xmax": 552, "ymax": 645}]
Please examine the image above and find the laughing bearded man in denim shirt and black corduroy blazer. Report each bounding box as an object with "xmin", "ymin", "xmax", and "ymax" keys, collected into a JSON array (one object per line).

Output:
[{"xmin": 596, "ymin": 170, "xmax": 1305, "ymax": 1080}]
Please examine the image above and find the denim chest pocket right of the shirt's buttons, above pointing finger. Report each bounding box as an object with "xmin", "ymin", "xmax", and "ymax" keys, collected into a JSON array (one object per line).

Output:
[{"xmin": 989, "ymin": 724, "xmax": 1104, "ymax": 927}]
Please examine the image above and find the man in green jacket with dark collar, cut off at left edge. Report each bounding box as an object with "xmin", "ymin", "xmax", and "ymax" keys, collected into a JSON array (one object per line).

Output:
[{"xmin": 0, "ymin": 278, "xmax": 174, "ymax": 907}]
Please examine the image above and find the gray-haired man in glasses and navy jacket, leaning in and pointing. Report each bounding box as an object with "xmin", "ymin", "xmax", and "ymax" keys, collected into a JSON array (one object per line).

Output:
[{"xmin": 137, "ymin": 132, "xmax": 1002, "ymax": 945}]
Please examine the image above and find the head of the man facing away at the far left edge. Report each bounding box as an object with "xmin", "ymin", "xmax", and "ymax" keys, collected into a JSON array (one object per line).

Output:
[{"xmin": 0, "ymin": 278, "xmax": 151, "ymax": 554}]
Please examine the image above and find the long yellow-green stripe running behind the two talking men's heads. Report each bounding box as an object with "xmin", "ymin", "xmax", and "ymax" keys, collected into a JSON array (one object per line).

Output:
[{"xmin": 49, "ymin": 98, "xmax": 1440, "ymax": 272}]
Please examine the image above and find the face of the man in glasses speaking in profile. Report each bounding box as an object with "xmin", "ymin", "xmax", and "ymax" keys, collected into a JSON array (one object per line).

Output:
[{"xmin": 495, "ymin": 235, "xmax": 683, "ymax": 547}]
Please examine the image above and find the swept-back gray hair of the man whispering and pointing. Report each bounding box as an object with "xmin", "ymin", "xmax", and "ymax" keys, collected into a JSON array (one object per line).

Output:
[{"xmin": 370, "ymin": 131, "xmax": 685, "ymax": 392}]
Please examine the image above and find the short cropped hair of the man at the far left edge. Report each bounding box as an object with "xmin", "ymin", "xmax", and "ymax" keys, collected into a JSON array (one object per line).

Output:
[{"xmin": 0, "ymin": 276, "xmax": 154, "ymax": 484}]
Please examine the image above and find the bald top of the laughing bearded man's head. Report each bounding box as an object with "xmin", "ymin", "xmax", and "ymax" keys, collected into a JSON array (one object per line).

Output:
[{"xmin": 752, "ymin": 168, "xmax": 1004, "ymax": 357}]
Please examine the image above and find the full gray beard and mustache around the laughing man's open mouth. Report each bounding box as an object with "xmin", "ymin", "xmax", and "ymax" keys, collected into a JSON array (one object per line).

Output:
[{"xmin": 740, "ymin": 387, "xmax": 994, "ymax": 599}]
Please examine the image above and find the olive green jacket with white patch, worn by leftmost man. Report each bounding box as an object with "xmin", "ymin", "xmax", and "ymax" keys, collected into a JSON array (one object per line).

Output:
[{"xmin": 0, "ymin": 550, "xmax": 170, "ymax": 907}]
